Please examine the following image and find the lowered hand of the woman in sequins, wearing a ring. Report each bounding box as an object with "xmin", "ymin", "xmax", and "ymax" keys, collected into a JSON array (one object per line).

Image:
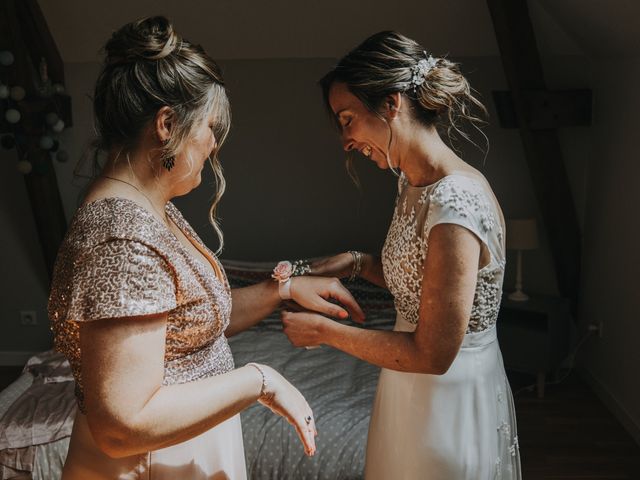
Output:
[{"xmin": 258, "ymin": 364, "xmax": 318, "ymax": 456}]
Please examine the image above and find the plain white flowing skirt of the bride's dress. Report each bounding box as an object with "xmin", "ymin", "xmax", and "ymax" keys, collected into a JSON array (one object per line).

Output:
[{"xmin": 365, "ymin": 316, "xmax": 522, "ymax": 480}]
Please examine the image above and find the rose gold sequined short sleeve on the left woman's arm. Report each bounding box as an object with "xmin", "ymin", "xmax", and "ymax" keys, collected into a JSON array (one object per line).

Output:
[{"xmin": 67, "ymin": 239, "xmax": 176, "ymax": 321}]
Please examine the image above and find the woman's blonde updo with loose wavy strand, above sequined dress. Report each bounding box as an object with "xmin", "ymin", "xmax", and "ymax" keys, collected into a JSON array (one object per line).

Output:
[{"xmin": 93, "ymin": 16, "xmax": 231, "ymax": 254}]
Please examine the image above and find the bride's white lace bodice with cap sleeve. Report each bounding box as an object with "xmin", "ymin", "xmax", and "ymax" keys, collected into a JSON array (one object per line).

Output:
[{"xmin": 382, "ymin": 174, "xmax": 505, "ymax": 333}]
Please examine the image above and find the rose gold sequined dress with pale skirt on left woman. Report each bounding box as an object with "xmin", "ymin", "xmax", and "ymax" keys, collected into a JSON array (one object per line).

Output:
[{"xmin": 49, "ymin": 198, "xmax": 246, "ymax": 480}]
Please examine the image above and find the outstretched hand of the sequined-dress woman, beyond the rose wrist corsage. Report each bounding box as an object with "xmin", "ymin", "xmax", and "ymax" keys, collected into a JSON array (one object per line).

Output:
[{"xmin": 291, "ymin": 275, "xmax": 365, "ymax": 323}]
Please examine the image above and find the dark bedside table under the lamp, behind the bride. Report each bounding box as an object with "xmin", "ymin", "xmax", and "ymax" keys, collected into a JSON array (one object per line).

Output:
[{"xmin": 498, "ymin": 295, "xmax": 571, "ymax": 398}]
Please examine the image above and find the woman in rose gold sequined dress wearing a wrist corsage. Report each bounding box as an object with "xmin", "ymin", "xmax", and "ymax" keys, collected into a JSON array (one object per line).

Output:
[{"xmin": 49, "ymin": 17, "xmax": 362, "ymax": 480}]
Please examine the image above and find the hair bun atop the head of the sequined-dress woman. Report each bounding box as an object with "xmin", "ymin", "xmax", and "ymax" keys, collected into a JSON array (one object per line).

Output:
[{"xmin": 104, "ymin": 16, "xmax": 182, "ymax": 65}]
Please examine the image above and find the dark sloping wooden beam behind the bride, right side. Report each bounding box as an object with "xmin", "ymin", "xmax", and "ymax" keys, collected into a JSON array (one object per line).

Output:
[{"xmin": 487, "ymin": 0, "xmax": 581, "ymax": 313}]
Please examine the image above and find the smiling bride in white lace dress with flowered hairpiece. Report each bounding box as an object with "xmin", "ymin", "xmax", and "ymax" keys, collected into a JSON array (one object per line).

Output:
[{"xmin": 283, "ymin": 32, "xmax": 521, "ymax": 480}]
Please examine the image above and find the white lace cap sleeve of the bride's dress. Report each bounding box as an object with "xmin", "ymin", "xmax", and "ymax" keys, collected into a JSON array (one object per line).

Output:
[{"xmin": 425, "ymin": 175, "xmax": 497, "ymax": 245}]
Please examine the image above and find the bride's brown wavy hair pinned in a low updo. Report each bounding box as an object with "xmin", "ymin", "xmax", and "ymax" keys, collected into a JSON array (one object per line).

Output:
[{"xmin": 319, "ymin": 31, "xmax": 488, "ymax": 178}]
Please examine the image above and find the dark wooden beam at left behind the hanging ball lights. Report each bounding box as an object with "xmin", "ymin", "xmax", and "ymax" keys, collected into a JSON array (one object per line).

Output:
[{"xmin": 0, "ymin": 0, "xmax": 71, "ymax": 278}]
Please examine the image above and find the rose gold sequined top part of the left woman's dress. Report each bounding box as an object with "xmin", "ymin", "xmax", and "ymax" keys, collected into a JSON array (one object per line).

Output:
[{"xmin": 49, "ymin": 198, "xmax": 234, "ymax": 411}]
